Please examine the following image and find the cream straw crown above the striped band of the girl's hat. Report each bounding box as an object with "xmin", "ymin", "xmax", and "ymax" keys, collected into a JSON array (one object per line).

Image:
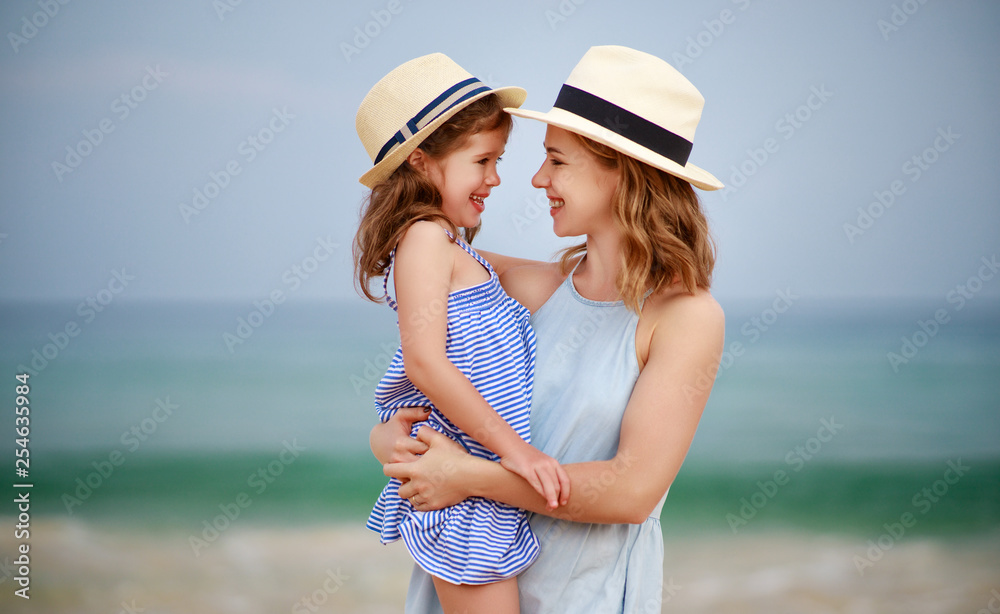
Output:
[{"xmin": 355, "ymin": 53, "xmax": 473, "ymax": 162}]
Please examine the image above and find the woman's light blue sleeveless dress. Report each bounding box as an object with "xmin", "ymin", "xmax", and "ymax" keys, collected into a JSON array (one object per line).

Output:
[{"xmin": 406, "ymin": 262, "xmax": 666, "ymax": 614}]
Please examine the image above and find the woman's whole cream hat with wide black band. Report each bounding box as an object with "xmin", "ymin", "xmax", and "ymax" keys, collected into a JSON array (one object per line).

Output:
[{"xmin": 506, "ymin": 45, "xmax": 723, "ymax": 190}]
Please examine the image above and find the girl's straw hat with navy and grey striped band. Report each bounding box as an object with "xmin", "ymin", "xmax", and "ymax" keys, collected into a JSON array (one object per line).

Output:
[{"xmin": 355, "ymin": 53, "xmax": 527, "ymax": 188}]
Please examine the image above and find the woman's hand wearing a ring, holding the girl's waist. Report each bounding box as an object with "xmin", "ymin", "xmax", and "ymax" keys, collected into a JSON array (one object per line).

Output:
[{"xmin": 382, "ymin": 427, "xmax": 474, "ymax": 512}]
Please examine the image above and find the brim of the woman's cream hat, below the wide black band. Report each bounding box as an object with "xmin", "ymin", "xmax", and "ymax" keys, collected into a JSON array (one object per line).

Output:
[{"xmin": 504, "ymin": 108, "xmax": 725, "ymax": 191}]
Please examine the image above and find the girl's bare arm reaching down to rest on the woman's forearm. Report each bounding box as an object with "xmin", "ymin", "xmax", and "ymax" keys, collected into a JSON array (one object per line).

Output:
[{"xmin": 395, "ymin": 222, "xmax": 569, "ymax": 506}]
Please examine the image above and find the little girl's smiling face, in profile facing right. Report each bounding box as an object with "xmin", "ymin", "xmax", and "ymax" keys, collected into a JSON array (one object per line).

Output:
[{"xmin": 410, "ymin": 130, "xmax": 507, "ymax": 228}]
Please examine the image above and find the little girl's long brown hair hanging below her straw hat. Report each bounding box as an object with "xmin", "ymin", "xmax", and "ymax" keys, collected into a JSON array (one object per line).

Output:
[{"xmin": 352, "ymin": 94, "xmax": 513, "ymax": 302}]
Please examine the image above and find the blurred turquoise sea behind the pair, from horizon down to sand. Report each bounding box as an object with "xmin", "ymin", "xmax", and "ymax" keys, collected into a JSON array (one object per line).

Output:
[{"xmin": 0, "ymin": 299, "xmax": 1000, "ymax": 532}]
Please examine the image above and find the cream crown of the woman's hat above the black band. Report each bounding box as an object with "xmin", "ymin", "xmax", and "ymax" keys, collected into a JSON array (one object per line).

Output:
[{"xmin": 566, "ymin": 45, "xmax": 705, "ymax": 142}]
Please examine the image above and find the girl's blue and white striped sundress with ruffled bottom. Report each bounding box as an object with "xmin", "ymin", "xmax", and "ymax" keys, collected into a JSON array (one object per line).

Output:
[{"xmin": 366, "ymin": 233, "xmax": 538, "ymax": 584}]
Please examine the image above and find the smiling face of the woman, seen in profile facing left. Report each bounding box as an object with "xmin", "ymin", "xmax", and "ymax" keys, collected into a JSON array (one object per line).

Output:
[{"xmin": 531, "ymin": 125, "xmax": 618, "ymax": 237}]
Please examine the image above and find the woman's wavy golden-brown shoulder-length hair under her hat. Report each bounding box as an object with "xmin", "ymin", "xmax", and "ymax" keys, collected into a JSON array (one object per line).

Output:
[{"xmin": 560, "ymin": 132, "xmax": 715, "ymax": 312}]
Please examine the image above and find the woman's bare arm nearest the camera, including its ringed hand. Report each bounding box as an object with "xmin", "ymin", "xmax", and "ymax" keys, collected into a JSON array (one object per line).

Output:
[{"xmin": 385, "ymin": 294, "xmax": 724, "ymax": 523}]
